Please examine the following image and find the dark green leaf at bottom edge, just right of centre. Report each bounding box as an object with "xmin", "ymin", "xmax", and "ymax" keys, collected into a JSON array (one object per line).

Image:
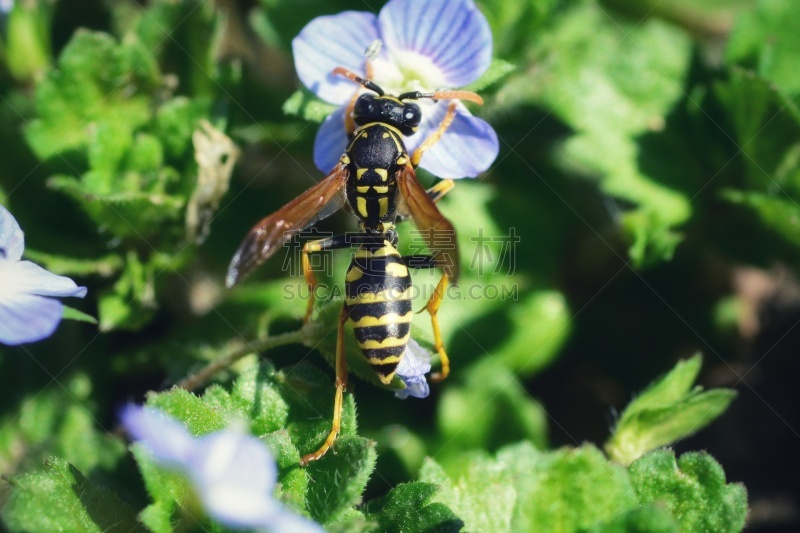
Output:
[{"xmin": 367, "ymin": 483, "xmax": 464, "ymax": 533}]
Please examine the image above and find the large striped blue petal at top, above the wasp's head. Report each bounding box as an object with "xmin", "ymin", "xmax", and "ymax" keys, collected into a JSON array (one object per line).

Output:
[{"xmin": 378, "ymin": 0, "xmax": 492, "ymax": 88}]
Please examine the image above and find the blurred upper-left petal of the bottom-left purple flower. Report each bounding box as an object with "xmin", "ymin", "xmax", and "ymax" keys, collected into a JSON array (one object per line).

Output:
[{"xmin": 120, "ymin": 405, "xmax": 195, "ymax": 466}]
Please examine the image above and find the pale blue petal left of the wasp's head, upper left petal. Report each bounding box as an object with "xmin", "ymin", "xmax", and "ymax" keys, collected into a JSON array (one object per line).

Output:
[{"xmin": 292, "ymin": 11, "xmax": 379, "ymax": 105}]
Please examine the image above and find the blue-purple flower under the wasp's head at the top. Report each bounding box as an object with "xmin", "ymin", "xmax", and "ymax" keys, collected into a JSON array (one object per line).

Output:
[{"xmin": 292, "ymin": 0, "xmax": 498, "ymax": 178}]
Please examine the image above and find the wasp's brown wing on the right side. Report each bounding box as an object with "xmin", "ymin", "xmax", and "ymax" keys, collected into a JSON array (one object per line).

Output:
[{"xmin": 397, "ymin": 165, "xmax": 459, "ymax": 283}]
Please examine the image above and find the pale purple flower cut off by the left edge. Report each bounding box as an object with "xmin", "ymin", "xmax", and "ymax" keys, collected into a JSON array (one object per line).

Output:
[{"xmin": 0, "ymin": 205, "xmax": 86, "ymax": 346}]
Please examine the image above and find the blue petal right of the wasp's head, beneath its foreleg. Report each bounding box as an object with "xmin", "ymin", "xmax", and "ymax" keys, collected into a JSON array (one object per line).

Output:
[{"xmin": 416, "ymin": 102, "xmax": 499, "ymax": 179}]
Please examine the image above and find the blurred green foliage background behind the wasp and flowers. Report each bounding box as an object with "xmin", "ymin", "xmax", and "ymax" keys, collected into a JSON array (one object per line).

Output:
[{"xmin": 0, "ymin": 0, "xmax": 800, "ymax": 531}]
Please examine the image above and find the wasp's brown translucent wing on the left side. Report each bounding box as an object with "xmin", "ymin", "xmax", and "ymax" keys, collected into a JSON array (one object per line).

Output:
[{"xmin": 225, "ymin": 164, "xmax": 349, "ymax": 287}]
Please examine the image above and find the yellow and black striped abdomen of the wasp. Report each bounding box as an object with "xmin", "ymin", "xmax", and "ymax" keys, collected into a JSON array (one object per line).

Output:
[{"xmin": 345, "ymin": 241, "xmax": 413, "ymax": 385}]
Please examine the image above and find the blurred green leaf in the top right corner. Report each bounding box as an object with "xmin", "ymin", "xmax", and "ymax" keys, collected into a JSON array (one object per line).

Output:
[{"xmin": 725, "ymin": 0, "xmax": 800, "ymax": 96}]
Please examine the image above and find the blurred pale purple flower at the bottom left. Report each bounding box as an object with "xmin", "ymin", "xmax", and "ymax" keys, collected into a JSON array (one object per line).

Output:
[{"xmin": 121, "ymin": 405, "xmax": 323, "ymax": 533}]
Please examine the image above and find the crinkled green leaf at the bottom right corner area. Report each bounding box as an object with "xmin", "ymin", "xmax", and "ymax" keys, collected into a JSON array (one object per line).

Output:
[{"xmin": 629, "ymin": 450, "xmax": 747, "ymax": 532}]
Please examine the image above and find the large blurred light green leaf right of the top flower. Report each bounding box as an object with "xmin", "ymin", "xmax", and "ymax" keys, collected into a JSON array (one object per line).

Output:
[{"xmin": 498, "ymin": 2, "xmax": 692, "ymax": 267}]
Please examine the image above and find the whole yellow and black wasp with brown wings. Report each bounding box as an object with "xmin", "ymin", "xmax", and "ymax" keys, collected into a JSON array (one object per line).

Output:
[{"xmin": 226, "ymin": 67, "xmax": 483, "ymax": 465}]
